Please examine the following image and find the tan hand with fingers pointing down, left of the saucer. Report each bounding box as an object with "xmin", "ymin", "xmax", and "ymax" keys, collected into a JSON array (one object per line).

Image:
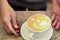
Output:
[{"xmin": 0, "ymin": 1, "xmax": 19, "ymax": 36}]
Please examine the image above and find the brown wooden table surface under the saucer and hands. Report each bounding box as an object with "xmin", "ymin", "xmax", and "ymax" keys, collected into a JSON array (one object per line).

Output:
[{"xmin": 0, "ymin": 11, "xmax": 60, "ymax": 40}]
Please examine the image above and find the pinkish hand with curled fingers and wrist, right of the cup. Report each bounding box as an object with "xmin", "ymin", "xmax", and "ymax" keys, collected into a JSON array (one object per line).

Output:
[{"xmin": 51, "ymin": 0, "xmax": 60, "ymax": 30}]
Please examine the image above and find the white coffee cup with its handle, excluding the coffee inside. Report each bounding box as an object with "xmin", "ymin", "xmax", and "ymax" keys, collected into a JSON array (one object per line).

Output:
[{"xmin": 26, "ymin": 14, "xmax": 51, "ymax": 40}]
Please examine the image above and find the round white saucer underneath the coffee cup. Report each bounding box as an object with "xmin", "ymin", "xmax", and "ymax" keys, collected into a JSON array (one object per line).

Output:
[{"xmin": 20, "ymin": 23, "xmax": 53, "ymax": 40}]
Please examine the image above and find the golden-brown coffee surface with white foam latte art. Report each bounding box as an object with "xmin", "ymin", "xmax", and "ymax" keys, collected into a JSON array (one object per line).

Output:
[{"xmin": 27, "ymin": 14, "xmax": 51, "ymax": 31}]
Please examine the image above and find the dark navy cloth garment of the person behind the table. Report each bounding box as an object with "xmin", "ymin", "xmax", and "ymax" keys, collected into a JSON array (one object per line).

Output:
[{"xmin": 8, "ymin": 0, "xmax": 47, "ymax": 9}]
